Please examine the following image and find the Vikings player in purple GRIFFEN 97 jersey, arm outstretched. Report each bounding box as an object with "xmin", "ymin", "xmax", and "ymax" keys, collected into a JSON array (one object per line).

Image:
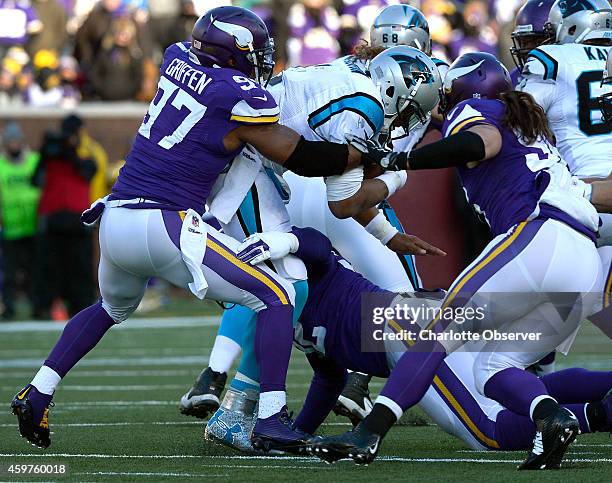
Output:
[{"xmin": 12, "ymin": 7, "xmax": 370, "ymax": 454}]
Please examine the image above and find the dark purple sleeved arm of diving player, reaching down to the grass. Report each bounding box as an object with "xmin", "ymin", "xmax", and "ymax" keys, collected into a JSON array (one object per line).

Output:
[{"xmin": 295, "ymin": 353, "xmax": 347, "ymax": 434}]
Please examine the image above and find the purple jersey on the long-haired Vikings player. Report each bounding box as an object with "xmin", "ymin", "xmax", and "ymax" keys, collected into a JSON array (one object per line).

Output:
[{"xmin": 442, "ymin": 99, "xmax": 561, "ymax": 236}]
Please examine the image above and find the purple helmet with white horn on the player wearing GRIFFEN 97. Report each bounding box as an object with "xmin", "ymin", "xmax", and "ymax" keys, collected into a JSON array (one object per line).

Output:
[{"xmin": 191, "ymin": 7, "xmax": 274, "ymax": 86}]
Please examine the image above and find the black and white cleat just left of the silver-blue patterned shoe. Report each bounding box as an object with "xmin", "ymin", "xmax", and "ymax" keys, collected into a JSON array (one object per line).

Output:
[{"xmin": 179, "ymin": 367, "xmax": 227, "ymax": 419}]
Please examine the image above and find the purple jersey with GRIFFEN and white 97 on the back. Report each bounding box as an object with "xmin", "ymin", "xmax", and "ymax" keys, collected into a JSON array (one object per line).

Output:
[{"xmin": 112, "ymin": 42, "xmax": 279, "ymax": 213}]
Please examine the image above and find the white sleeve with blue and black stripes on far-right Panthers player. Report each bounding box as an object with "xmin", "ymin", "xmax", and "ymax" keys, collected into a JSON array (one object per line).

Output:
[{"xmin": 517, "ymin": 49, "xmax": 559, "ymax": 112}]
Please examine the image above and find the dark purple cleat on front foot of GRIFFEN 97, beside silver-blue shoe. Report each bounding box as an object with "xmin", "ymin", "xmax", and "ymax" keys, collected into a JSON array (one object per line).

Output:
[{"xmin": 251, "ymin": 406, "xmax": 312, "ymax": 454}]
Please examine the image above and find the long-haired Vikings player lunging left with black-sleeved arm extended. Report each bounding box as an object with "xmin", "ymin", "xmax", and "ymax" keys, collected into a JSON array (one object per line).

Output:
[{"xmin": 315, "ymin": 53, "xmax": 602, "ymax": 469}]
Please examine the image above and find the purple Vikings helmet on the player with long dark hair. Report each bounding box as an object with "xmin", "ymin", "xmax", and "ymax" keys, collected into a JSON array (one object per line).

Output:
[{"xmin": 440, "ymin": 52, "xmax": 512, "ymax": 113}]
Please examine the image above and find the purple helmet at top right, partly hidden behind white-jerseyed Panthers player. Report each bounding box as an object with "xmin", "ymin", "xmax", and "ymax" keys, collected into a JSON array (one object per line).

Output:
[{"xmin": 510, "ymin": 0, "xmax": 556, "ymax": 70}]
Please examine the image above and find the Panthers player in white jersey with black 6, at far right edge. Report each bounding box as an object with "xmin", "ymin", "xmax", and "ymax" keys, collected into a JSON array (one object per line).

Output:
[{"xmin": 519, "ymin": 0, "xmax": 612, "ymax": 246}]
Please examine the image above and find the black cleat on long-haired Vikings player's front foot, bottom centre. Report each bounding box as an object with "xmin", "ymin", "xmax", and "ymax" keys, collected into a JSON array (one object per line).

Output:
[{"xmin": 308, "ymin": 424, "xmax": 381, "ymax": 465}]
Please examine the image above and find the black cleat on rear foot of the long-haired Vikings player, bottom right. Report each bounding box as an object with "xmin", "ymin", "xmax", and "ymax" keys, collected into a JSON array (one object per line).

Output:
[{"xmin": 518, "ymin": 408, "xmax": 580, "ymax": 470}]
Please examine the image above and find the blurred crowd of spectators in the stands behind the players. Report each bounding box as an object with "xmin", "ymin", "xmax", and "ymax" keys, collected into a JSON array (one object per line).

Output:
[{"xmin": 0, "ymin": 0, "xmax": 521, "ymax": 108}]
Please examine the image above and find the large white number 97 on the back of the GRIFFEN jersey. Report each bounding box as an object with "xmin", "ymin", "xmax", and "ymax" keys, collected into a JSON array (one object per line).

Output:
[{"xmin": 138, "ymin": 77, "xmax": 206, "ymax": 149}]
